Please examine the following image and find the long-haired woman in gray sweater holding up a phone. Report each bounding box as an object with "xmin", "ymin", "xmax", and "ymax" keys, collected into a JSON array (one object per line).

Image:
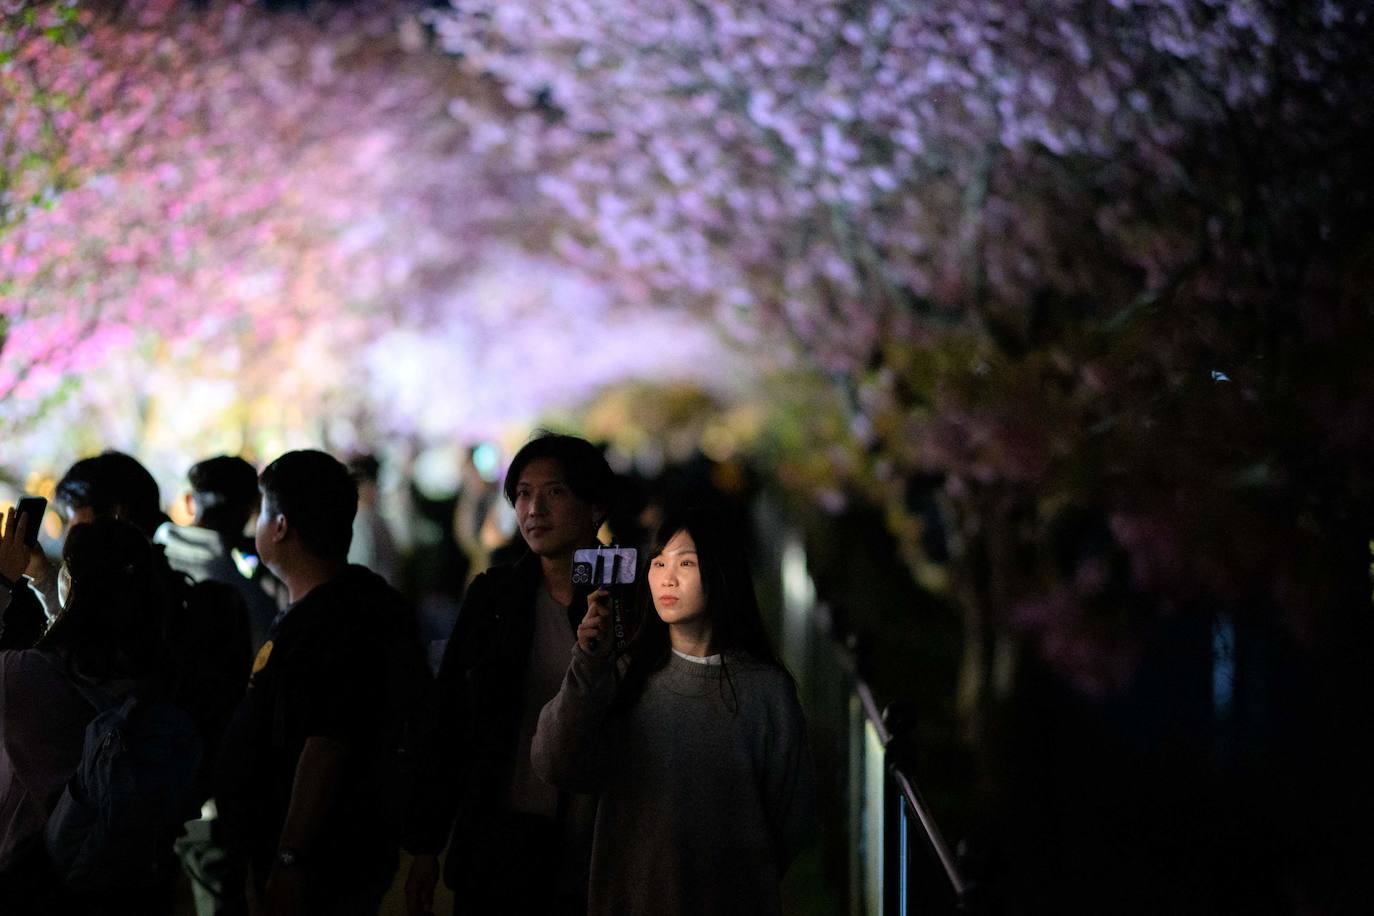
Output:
[{"xmin": 532, "ymin": 509, "xmax": 815, "ymax": 916}]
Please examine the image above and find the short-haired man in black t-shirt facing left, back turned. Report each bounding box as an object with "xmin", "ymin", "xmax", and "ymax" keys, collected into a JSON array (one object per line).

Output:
[{"xmin": 216, "ymin": 450, "xmax": 427, "ymax": 916}]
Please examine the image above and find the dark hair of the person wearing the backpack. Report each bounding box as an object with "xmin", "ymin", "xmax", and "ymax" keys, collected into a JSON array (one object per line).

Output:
[{"xmin": 38, "ymin": 518, "xmax": 172, "ymax": 683}]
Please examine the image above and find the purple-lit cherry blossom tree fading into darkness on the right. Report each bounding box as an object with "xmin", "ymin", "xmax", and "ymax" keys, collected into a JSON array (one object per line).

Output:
[{"xmin": 433, "ymin": 0, "xmax": 1374, "ymax": 714}]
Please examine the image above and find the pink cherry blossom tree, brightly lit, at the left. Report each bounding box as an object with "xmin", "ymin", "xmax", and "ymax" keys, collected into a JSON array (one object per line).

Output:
[{"xmin": 0, "ymin": 0, "xmax": 752, "ymax": 486}]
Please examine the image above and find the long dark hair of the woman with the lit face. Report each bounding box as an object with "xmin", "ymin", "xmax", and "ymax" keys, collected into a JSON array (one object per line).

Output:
[{"xmin": 617, "ymin": 507, "xmax": 787, "ymax": 709}]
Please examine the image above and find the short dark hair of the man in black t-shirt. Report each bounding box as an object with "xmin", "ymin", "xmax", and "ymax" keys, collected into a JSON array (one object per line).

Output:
[{"xmin": 258, "ymin": 449, "xmax": 357, "ymax": 559}]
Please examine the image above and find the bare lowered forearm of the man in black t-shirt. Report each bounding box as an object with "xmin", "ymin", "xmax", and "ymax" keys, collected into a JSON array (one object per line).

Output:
[{"xmin": 264, "ymin": 736, "xmax": 348, "ymax": 916}]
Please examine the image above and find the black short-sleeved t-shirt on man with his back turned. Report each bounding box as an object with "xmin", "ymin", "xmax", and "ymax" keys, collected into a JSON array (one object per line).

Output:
[{"xmin": 216, "ymin": 566, "xmax": 414, "ymax": 876}]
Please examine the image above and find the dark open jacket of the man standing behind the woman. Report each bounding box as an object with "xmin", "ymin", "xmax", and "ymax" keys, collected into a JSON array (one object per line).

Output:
[{"xmin": 408, "ymin": 553, "xmax": 587, "ymax": 889}]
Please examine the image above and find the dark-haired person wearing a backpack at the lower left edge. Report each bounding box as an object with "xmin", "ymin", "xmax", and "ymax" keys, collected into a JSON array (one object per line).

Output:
[{"xmin": 0, "ymin": 516, "xmax": 186, "ymax": 916}]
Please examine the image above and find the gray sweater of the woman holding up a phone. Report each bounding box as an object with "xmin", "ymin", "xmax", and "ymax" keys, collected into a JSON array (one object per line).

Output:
[{"xmin": 530, "ymin": 647, "xmax": 815, "ymax": 916}]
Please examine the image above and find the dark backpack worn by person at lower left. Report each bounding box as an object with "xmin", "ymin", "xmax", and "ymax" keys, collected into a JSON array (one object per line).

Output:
[{"xmin": 44, "ymin": 680, "xmax": 201, "ymax": 893}]
